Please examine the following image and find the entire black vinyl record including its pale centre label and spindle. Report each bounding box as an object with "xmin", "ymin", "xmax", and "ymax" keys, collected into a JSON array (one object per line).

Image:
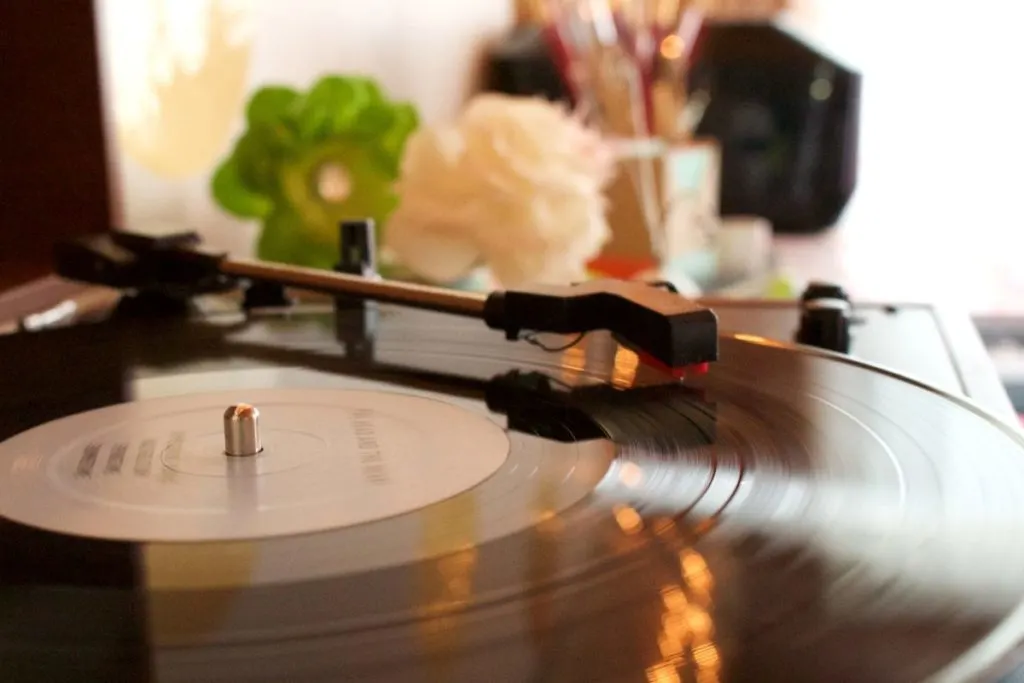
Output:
[{"xmin": 0, "ymin": 306, "xmax": 1024, "ymax": 683}]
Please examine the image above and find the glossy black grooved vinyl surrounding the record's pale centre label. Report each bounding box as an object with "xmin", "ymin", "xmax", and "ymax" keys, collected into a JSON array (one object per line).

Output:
[{"xmin": 0, "ymin": 309, "xmax": 1024, "ymax": 683}]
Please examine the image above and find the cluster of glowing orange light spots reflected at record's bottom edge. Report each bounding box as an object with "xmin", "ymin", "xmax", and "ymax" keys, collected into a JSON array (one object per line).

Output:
[{"xmin": 646, "ymin": 549, "xmax": 722, "ymax": 683}]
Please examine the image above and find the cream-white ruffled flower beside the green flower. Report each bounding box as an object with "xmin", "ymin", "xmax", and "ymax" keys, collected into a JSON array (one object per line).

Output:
[{"xmin": 385, "ymin": 94, "xmax": 614, "ymax": 287}]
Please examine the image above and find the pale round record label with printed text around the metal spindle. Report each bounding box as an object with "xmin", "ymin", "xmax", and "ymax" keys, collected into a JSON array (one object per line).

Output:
[{"xmin": 0, "ymin": 389, "xmax": 509, "ymax": 542}]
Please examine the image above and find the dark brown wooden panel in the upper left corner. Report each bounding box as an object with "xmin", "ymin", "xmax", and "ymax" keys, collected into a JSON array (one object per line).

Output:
[{"xmin": 0, "ymin": 0, "xmax": 111, "ymax": 289}]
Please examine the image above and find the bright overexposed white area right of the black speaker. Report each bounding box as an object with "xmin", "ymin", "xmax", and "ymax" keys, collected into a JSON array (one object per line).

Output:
[{"xmin": 783, "ymin": 0, "xmax": 1024, "ymax": 312}]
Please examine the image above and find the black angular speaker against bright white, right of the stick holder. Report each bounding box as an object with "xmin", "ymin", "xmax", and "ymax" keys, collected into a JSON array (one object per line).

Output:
[{"xmin": 688, "ymin": 24, "xmax": 861, "ymax": 233}]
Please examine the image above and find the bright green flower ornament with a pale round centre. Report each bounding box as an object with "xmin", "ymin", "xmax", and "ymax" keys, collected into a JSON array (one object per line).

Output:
[{"xmin": 212, "ymin": 76, "xmax": 418, "ymax": 268}]
